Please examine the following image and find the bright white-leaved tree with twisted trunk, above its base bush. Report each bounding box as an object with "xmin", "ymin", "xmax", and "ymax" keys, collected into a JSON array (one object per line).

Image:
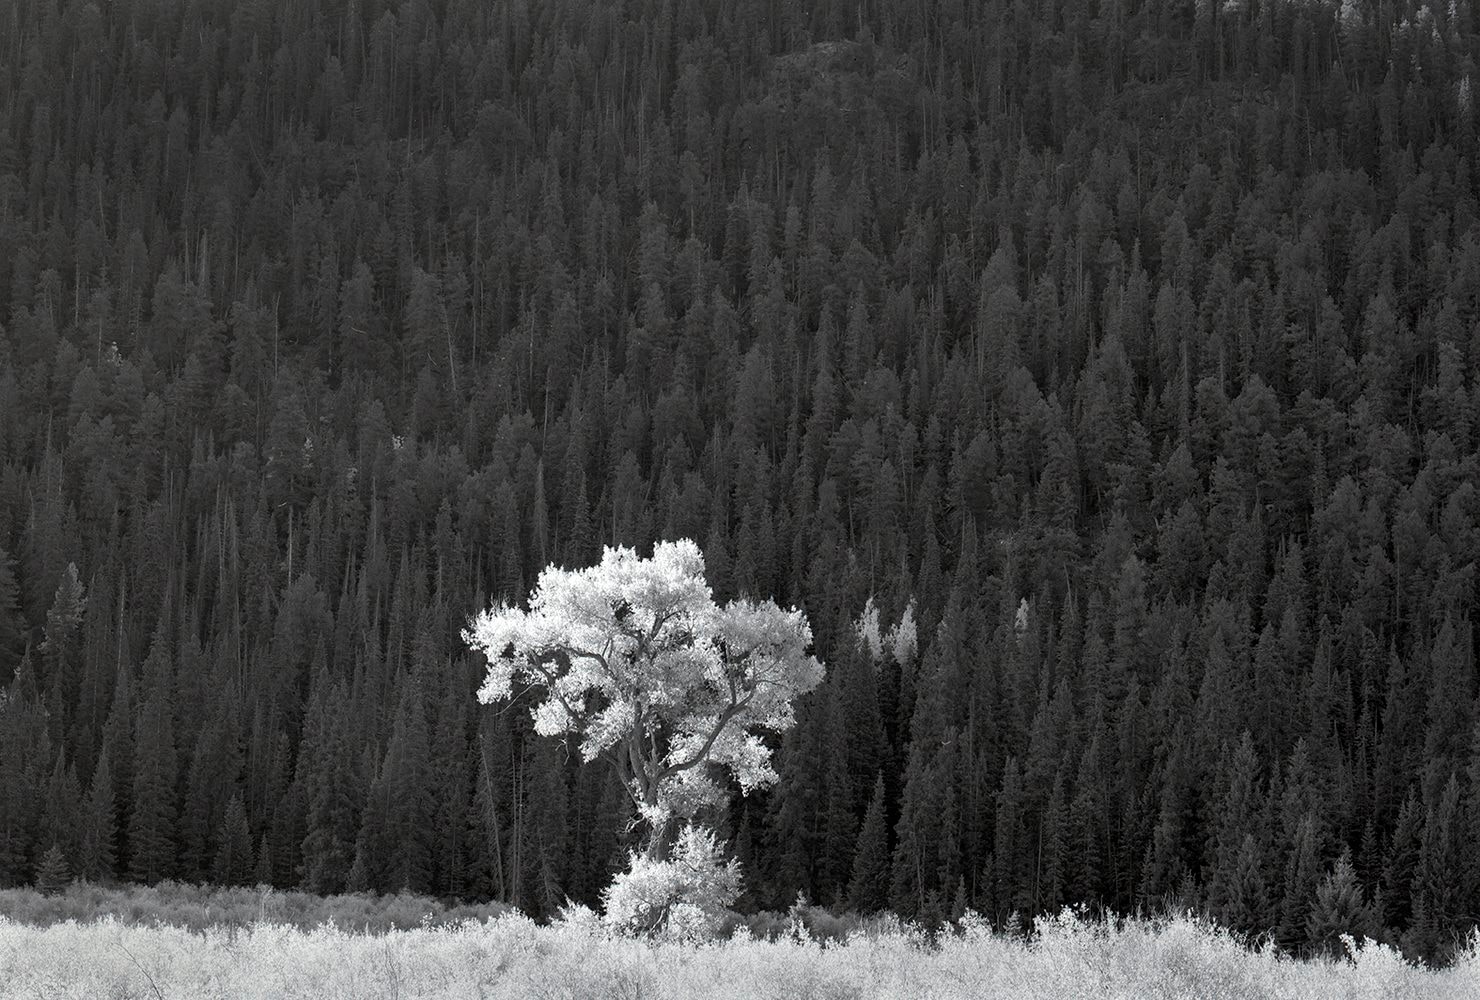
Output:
[{"xmin": 463, "ymin": 538, "xmax": 823, "ymax": 910}]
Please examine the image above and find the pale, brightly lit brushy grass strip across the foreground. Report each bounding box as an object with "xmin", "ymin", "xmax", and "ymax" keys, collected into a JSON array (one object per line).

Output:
[{"xmin": 0, "ymin": 896, "xmax": 1480, "ymax": 1000}]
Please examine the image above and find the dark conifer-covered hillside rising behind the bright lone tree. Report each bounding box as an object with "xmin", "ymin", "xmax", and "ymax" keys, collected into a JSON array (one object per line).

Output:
[{"xmin": 0, "ymin": 0, "xmax": 1480, "ymax": 957}]
